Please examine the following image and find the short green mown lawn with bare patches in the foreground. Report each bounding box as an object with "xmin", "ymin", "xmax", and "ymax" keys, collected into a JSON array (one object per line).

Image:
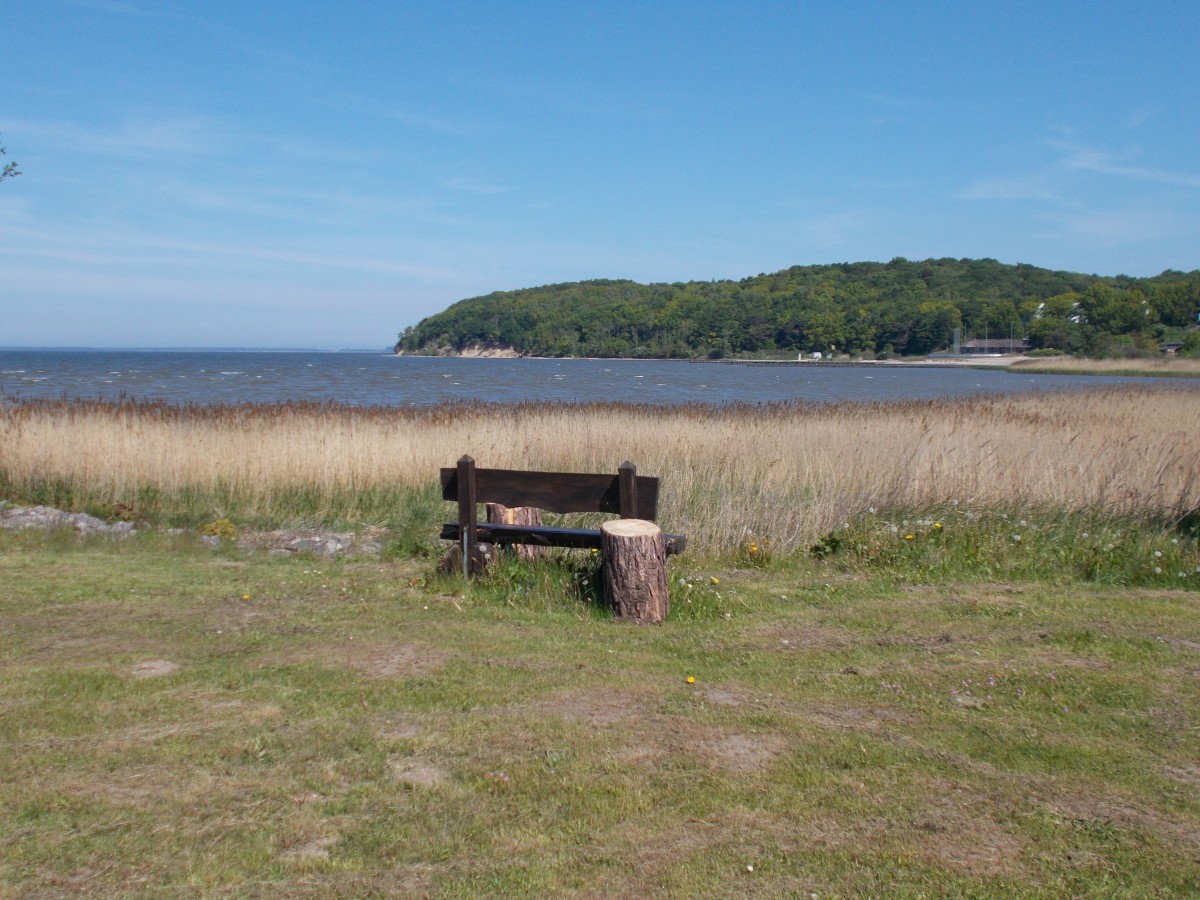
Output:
[{"xmin": 0, "ymin": 525, "xmax": 1200, "ymax": 896}]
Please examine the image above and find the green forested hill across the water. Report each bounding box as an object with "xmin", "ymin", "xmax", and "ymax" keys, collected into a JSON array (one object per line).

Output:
[{"xmin": 396, "ymin": 259, "xmax": 1200, "ymax": 358}]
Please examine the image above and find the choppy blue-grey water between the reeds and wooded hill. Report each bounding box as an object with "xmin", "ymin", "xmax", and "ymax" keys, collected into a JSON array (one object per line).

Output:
[{"xmin": 0, "ymin": 350, "xmax": 1180, "ymax": 407}]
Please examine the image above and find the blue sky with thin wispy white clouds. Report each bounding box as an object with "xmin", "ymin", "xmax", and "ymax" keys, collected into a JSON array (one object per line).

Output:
[{"xmin": 0, "ymin": 0, "xmax": 1200, "ymax": 348}]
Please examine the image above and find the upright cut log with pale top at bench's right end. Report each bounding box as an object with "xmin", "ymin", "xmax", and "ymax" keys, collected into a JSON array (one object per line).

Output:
[{"xmin": 600, "ymin": 518, "xmax": 670, "ymax": 624}]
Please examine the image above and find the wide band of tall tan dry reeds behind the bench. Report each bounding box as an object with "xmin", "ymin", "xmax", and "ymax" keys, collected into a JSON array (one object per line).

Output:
[{"xmin": 0, "ymin": 386, "xmax": 1200, "ymax": 550}]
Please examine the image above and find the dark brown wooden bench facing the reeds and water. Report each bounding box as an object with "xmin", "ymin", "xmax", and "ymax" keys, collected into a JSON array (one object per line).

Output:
[{"xmin": 442, "ymin": 456, "xmax": 688, "ymax": 576}]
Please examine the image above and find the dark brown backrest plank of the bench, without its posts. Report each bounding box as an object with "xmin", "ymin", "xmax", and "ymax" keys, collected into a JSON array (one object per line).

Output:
[{"xmin": 442, "ymin": 468, "xmax": 659, "ymax": 522}]
